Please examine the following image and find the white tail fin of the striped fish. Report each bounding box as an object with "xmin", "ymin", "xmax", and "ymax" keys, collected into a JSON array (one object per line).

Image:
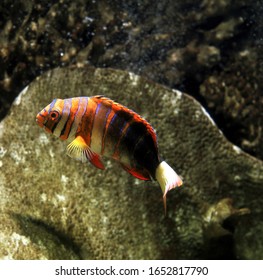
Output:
[{"xmin": 155, "ymin": 161, "xmax": 183, "ymax": 213}]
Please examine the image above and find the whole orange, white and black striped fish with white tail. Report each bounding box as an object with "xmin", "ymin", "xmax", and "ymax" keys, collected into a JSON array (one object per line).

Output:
[{"xmin": 36, "ymin": 96, "xmax": 182, "ymax": 209}]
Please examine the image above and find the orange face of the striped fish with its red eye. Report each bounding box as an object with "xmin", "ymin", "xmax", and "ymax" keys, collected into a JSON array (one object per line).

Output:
[{"xmin": 36, "ymin": 99, "xmax": 62, "ymax": 133}]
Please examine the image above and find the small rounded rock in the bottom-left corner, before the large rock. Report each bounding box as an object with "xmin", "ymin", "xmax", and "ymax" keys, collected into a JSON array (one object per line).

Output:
[{"xmin": 0, "ymin": 213, "xmax": 79, "ymax": 260}]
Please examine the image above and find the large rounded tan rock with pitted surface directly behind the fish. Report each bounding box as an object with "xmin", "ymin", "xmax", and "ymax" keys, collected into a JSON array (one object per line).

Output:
[{"xmin": 0, "ymin": 67, "xmax": 263, "ymax": 259}]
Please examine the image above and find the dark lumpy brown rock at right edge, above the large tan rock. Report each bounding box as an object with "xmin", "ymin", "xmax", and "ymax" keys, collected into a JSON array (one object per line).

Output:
[{"xmin": 200, "ymin": 48, "xmax": 263, "ymax": 159}]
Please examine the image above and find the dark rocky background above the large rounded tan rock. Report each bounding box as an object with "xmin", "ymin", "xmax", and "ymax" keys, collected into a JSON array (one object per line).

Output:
[{"xmin": 0, "ymin": 0, "xmax": 263, "ymax": 159}]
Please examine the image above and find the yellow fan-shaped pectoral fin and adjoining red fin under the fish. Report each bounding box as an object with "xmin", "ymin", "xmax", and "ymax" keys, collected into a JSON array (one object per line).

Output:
[{"xmin": 67, "ymin": 136, "xmax": 105, "ymax": 169}]
